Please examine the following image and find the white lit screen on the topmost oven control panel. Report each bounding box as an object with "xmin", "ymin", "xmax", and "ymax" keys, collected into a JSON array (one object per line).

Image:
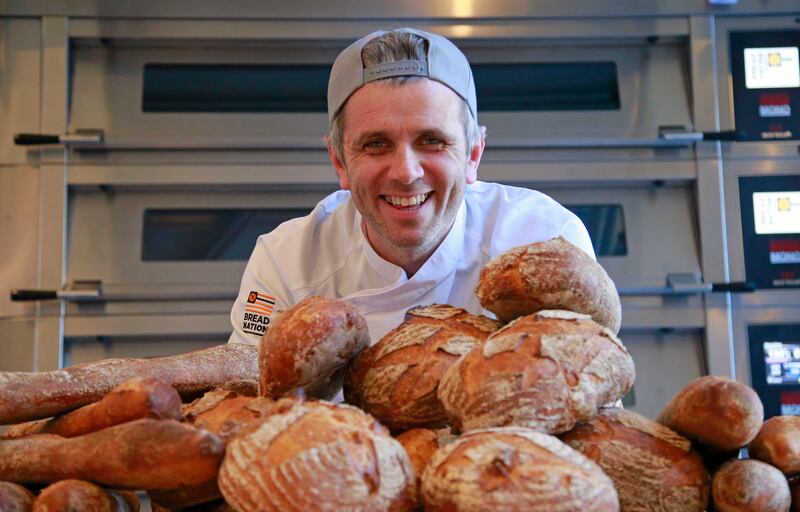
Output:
[{"xmin": 744, "ymin": 46, "xmax": 800, "ymax": 89}]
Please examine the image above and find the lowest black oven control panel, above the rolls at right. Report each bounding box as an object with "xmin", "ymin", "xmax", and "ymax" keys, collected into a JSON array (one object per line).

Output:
[{"xmin": 747, "ymin": 324, "xmax": 800, "ymax": 419}]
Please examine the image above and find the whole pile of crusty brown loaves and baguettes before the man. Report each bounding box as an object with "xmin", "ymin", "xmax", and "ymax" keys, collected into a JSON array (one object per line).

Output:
[{"xmin": 0, "ymin": 238, "xmax": 800, "ymax": 512}]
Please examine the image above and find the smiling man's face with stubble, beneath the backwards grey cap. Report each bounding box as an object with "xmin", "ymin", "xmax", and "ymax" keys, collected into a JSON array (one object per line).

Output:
[{"xmin": 331, "ymin": 79, "xmax": 483, "ymax": 268}]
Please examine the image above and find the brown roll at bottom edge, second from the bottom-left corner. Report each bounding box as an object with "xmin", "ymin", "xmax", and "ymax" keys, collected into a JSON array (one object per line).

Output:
[{"xmin": 33, "ymin": 480, "xmax": 139, "ymax": 512}]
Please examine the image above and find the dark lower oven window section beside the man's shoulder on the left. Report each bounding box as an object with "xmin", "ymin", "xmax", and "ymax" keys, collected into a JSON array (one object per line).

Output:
[{"xmin": 142, "ymin": 208, "xmax": 310, "ymax": 261}]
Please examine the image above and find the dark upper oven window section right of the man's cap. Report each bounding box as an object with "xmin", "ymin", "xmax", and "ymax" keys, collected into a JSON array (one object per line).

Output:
[{"xmin": 472, "ymin": 61, "xmax": 620, "ymax": 112}]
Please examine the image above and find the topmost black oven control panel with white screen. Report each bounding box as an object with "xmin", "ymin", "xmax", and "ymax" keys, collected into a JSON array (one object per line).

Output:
[{"xmin": 730, "ymin": 30, "xmax": 800, "ymax": 140}]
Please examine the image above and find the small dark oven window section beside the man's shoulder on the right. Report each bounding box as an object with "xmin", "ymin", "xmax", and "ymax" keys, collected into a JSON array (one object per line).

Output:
[{"xmin": 564, "ymin": 204, "xmax": 628, "ymax": 256}]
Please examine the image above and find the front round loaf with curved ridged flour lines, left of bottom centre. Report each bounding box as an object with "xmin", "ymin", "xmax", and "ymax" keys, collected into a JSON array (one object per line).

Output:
[{"xmin": 219, "ymin": 398, "xmax": 416, "ymax": 512}]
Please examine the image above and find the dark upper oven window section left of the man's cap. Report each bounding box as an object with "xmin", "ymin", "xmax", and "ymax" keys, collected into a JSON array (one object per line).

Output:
[{"xmin": 142, "ymin": 63, "xmax": 331, "ymax": 112}]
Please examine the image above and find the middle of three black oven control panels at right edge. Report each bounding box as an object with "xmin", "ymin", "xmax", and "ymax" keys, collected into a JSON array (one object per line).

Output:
[{"xmin": 739, "ymin": 174, "xmax": 800, "ymax": 289}]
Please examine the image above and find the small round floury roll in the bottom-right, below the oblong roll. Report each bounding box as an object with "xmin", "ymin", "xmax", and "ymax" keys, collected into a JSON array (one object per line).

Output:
[{"xmin": 711, "ymin": 459, "xmax": 791, "ymax": 512}]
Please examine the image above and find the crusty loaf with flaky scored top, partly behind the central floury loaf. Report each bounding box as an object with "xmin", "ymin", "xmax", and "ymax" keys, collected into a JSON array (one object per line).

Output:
[{"xmin": 344, "ymin": 304, "xmax": 500, "ymax": 431}]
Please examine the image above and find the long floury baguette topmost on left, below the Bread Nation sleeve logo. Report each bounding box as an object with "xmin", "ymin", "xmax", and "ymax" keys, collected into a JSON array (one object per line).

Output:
[{"xmin": 0, "ymin": 343, "xmax": 258, "ymax": 425}]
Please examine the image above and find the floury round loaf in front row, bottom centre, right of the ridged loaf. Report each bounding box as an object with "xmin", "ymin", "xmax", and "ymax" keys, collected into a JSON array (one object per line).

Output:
[{"xmin": 422, "ymin": 427, "xmax": 619, "ymax": 512}]
